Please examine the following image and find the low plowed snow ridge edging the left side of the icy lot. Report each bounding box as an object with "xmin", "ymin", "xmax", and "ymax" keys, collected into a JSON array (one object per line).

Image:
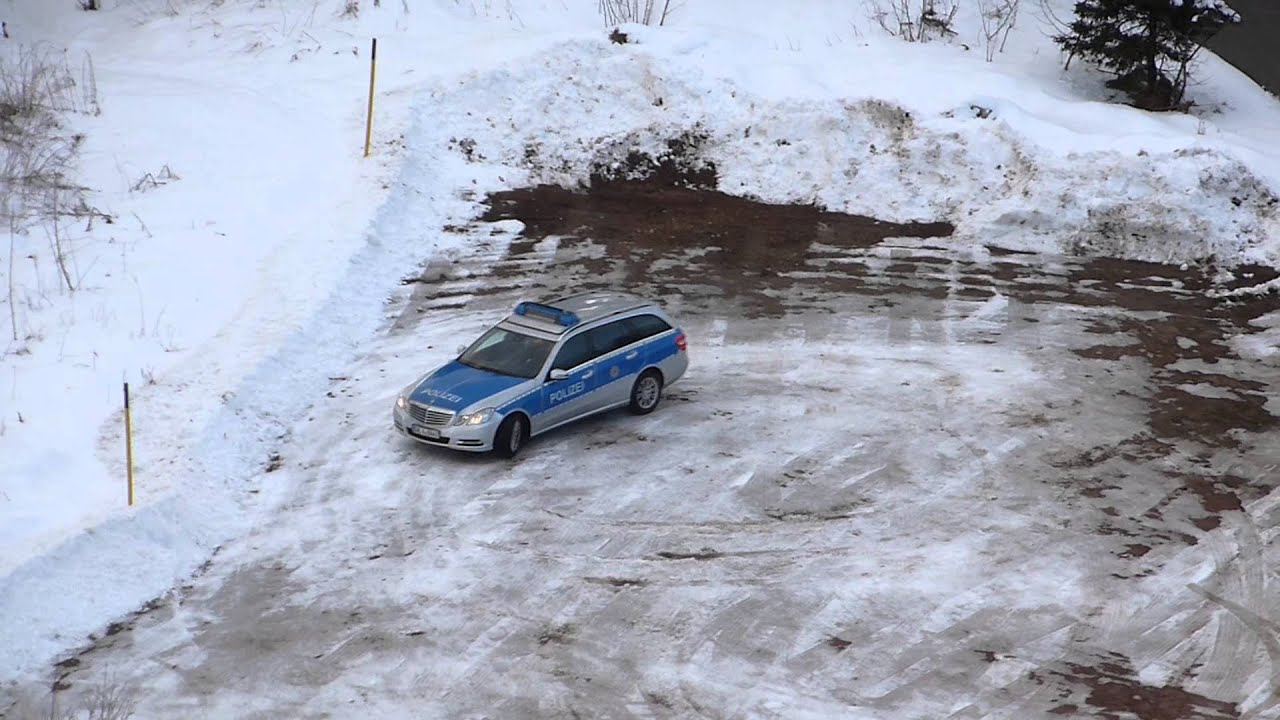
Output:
[{"xmin": 0, "ymin": 75, "xmax": 481, "ymax": 678}]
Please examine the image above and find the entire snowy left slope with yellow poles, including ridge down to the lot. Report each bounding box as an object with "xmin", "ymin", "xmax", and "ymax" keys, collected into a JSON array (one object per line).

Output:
[{"xmin": 0, "ymin": 3, "xmax": 601, "ymax": 675}]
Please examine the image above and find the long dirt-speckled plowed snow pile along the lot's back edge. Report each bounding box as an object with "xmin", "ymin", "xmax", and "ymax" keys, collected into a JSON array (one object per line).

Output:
[{"xmin": 431, "ymin": 28, "xmax": 1280, "ymax": 265}]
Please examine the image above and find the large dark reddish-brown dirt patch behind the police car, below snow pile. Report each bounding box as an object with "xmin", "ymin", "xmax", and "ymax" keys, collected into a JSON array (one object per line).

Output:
[{"xmin": 480, "ymin": 173, "xmax": 954, "ymax": 316}]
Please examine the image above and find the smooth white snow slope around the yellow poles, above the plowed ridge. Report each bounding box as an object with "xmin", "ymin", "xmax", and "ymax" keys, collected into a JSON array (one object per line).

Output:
[{"xmin": 0, "ymin": 3, "xmax": 599, "ymax": 571}]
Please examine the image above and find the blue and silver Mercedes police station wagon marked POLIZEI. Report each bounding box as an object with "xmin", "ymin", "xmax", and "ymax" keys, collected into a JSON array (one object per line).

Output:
[{"xmin": 393, "ymin": 292, "xmax": 689, "ymax": 457}]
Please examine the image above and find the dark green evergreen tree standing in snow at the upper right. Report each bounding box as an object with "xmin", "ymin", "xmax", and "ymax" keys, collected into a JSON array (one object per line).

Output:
[{"xmin": 1053, "ymin": 0, "xmax": 1240, "ymax": 110}]
